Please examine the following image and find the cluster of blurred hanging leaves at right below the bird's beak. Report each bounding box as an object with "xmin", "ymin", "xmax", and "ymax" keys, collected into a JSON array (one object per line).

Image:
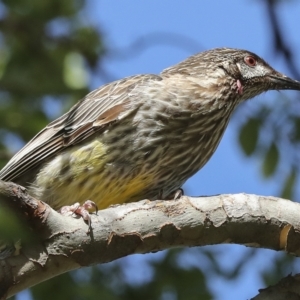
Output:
[{"xmin": 238, "ymin": 93, "xmax": 300, "ymax": 200}]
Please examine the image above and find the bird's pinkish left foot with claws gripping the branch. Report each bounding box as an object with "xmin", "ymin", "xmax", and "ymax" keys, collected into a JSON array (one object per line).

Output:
[{"xmin": 59, "ymin": 200, "xmax": 98, "ymax": 233}]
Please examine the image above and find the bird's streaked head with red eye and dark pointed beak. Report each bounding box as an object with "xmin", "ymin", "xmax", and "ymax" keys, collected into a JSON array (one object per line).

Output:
[{"xmin": 164, "ymin": 48, "xmax": 300, "ymax": 100}]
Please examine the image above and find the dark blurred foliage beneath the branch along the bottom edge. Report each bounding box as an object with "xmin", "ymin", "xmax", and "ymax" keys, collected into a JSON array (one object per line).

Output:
[{"xmin": 32, "ymin": 250, "xmax": 212, "ymax": 300}]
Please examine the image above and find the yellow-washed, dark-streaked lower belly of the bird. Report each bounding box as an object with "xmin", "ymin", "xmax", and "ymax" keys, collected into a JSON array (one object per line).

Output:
[{"xmin": 29, "ymin": 139, "xmax": 155, "ymax": 209}]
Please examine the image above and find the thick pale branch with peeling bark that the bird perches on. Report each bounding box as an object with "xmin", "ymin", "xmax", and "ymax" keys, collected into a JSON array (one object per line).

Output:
[{"xmin": 0, "ymin": 181, "xmax": 300, "ymax": 299}]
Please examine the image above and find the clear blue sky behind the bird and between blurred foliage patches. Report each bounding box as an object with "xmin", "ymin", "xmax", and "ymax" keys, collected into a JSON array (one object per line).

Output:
[{"xmin": 15, "ymin": 0, "xmax": 300, "ymax": 300}]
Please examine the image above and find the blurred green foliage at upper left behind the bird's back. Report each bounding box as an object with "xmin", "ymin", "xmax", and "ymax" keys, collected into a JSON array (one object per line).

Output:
[{"xmin": 0, "ymin": 0, "xmax": 104, "ymax": 165}]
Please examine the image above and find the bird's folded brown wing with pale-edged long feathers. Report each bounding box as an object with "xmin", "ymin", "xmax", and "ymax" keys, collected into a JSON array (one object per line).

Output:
[{"xmin": 0, "ymin": 75, "xmax": 161, "ymax": 180}]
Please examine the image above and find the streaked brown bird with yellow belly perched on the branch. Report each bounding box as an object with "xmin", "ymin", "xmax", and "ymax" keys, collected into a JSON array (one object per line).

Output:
[{"xmin": 0, "ymin": 48, "xmax": 300, "ymax": 216}]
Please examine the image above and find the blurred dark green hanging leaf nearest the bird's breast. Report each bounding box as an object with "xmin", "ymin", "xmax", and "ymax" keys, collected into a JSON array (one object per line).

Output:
[{"xmin": 239, "ymin": 118, "xmax": 261, "ymax": 155}]
